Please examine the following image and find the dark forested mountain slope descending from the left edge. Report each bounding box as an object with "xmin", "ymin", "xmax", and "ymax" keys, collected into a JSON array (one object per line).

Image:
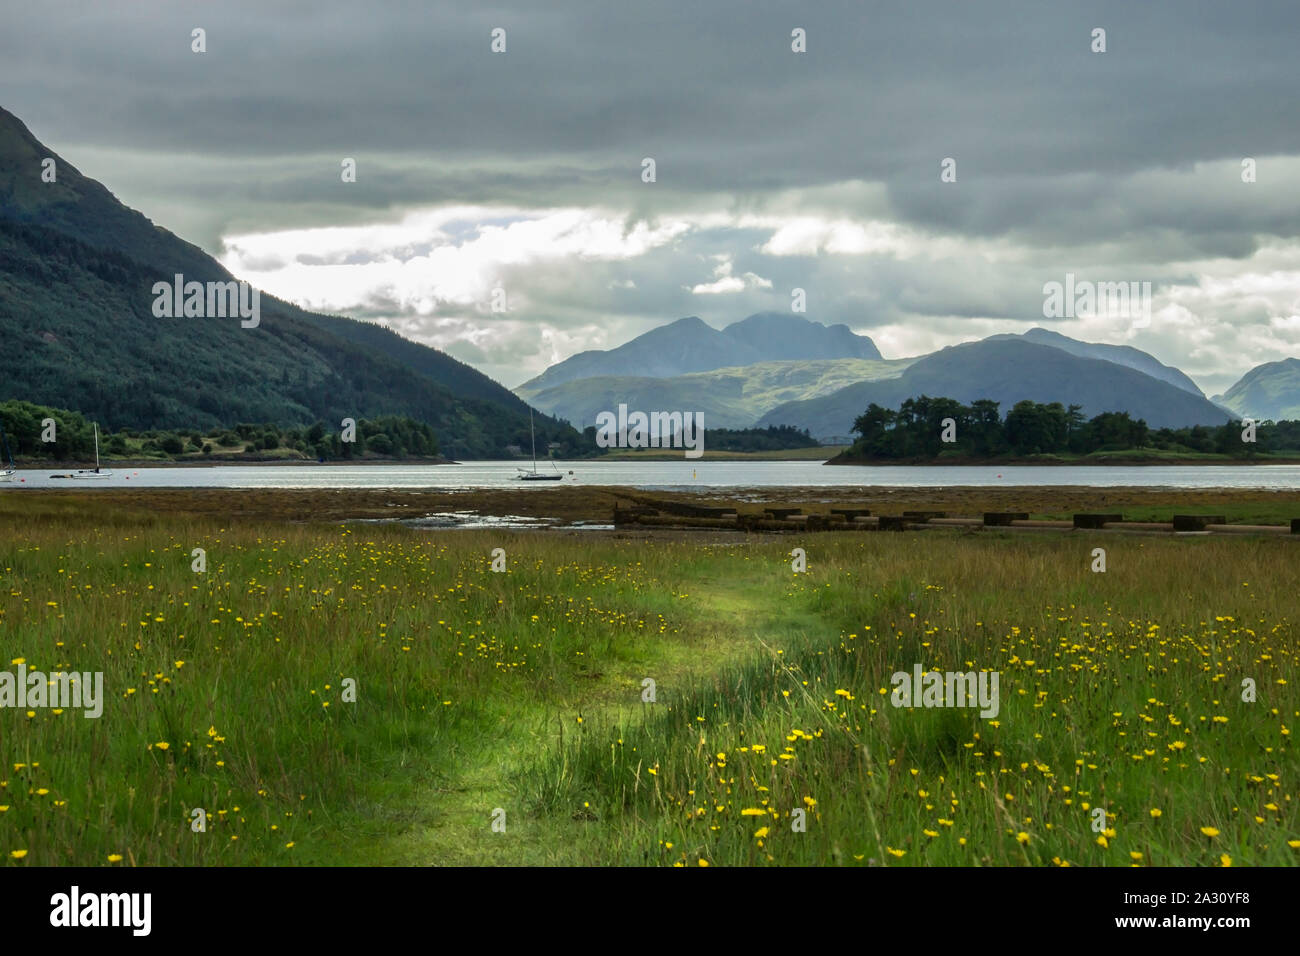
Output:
[{"xmin": 0, "ymin": 111, "xmax": 579, "ymax": 458}]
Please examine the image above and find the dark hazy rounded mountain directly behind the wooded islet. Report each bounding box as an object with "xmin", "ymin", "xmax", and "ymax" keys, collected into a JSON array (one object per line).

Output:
[{"xmin": 758, "ymin": 336, "xmax": 1229, "ymax": 437}]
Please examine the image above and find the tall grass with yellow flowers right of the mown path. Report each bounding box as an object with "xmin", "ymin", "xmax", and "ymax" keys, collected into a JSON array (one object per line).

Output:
[{"xmin": 520, "ymin": 536, "xmax": 1300, "ymax": 865}]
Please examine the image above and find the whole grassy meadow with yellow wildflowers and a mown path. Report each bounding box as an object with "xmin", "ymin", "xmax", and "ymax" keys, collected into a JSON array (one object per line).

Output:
[{"xmin": 0, "ymin": 493, "xmax": 1300, "ymax": 866}]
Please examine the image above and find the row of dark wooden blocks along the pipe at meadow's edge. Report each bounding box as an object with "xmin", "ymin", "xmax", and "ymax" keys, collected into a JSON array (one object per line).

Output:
[{"xmin": 614, "ymin": 501, "xmax": 1300, "ymax": 535}]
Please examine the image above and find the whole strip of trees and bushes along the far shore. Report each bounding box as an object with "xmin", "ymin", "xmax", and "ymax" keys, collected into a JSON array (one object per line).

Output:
[{"xmin": 0, "ymin": 395, "xmax": 1300, "ymax": 468}]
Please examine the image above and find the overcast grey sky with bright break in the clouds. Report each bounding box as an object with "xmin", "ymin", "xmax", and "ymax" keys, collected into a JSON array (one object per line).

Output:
[{"xmin": 0, "ymin": 0, "xmax": 1300, "ymax": 394}]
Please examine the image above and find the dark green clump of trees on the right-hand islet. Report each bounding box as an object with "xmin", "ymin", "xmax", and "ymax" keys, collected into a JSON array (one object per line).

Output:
[{"xmin": 845, "ymin": 395, "xmax": 1300, "ymax": 459}]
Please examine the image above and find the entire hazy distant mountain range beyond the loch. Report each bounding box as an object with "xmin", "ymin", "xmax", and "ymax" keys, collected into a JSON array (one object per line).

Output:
[{"xmin": 516, "ymin": 313, "xmax": 1300, "ymax": 441}]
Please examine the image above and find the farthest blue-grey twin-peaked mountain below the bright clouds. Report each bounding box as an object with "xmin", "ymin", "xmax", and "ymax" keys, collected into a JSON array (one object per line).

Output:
[{"xmin": 516, "ymin": 312, "xmax": 880, "ymax": 394}]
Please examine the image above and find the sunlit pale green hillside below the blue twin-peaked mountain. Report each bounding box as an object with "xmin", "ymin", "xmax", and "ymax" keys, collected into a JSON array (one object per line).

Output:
[{"xmin": 520, "ymin": 359, "xmax": 913, "ymax": 428}]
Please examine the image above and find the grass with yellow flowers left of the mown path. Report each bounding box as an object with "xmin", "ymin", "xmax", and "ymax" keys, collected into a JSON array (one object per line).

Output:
[{"xmin": 0, "ymin": 519, "xmax": 702, "ymax": 865}]
